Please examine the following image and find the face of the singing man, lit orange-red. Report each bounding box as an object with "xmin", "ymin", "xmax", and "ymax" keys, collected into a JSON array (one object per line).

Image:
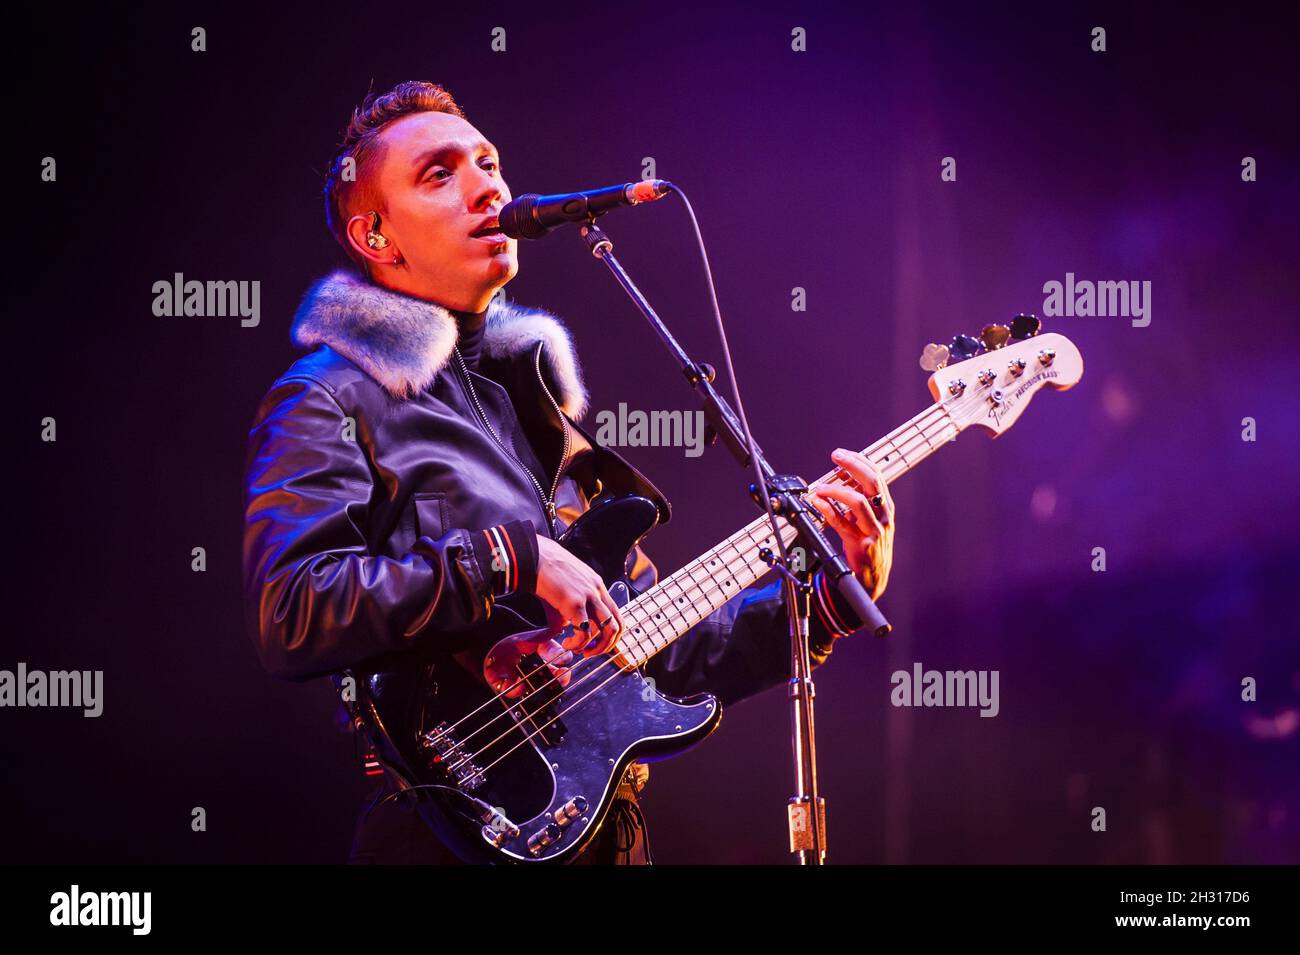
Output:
[{"xmin": 371, "ymin": 113, "xmax": 519, "ymax": 312}]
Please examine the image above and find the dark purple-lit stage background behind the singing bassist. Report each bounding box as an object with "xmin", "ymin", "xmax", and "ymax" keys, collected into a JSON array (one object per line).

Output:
[{"xmin": 0, "ymin": 3, "xmax": 1300, "ymax": 863}]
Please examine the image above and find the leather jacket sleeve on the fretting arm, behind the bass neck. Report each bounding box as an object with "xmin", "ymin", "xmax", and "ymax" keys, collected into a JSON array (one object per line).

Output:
[{"xmin": 637, "ymin": 548, "xmax": 861, "ymax": 707}]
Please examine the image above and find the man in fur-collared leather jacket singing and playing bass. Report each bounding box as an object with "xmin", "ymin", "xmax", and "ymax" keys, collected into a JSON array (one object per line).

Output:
[{"xmin": 243, "ymin": 82, "xmax": 893, "ymax": 863}]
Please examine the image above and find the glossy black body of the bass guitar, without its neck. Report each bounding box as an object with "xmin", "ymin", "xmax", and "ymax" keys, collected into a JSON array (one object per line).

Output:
[{"xmin": 355, "ymin": 495, "xmax": 722, "ymax": 863}]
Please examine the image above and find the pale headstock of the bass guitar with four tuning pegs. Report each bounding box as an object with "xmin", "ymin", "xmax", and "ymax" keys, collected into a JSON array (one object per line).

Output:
[{"xmin": 920, "ymin": 314, "xmax": 1083, "ymax": 438}]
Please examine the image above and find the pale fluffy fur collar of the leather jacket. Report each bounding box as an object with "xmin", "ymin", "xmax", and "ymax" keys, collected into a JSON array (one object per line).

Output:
[{"xmin": 290, "ymin": 269, "xmax": 588, "ymax": 421}]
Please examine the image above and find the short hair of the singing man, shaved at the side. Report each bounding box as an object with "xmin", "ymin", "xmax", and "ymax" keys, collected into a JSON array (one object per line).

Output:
[{"xmin": 325, "ymin": 81, "xmax": 465, "ymax": 274}]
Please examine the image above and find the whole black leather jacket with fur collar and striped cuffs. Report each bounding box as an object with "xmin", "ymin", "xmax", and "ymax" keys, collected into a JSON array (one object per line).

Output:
[{"xmin": 243, "ymin": 272, "xmax": 855, "ymax": 722}]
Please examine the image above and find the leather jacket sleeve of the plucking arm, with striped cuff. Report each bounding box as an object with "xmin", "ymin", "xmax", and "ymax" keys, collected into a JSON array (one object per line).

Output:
[{"xmin": 243, "ymin": 378, "xmax": 537, "ymax": 680}]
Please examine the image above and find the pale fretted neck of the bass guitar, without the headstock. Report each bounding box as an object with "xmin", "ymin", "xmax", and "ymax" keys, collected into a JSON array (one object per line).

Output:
[{"xmin": 619, "ymin": 401, "xmax": 961, "ymax": 667}]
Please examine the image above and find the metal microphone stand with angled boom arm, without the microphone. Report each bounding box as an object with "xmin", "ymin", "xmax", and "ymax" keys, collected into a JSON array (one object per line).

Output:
[{"xmin": 580, "ymin": 217, "xmax": 891, "ymax": 865}]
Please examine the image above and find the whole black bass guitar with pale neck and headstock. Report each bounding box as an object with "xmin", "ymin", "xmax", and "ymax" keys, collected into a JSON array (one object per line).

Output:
[{"xmin": 351, "ymin": 324, "xmax": 1083, "ymax": 863}]
